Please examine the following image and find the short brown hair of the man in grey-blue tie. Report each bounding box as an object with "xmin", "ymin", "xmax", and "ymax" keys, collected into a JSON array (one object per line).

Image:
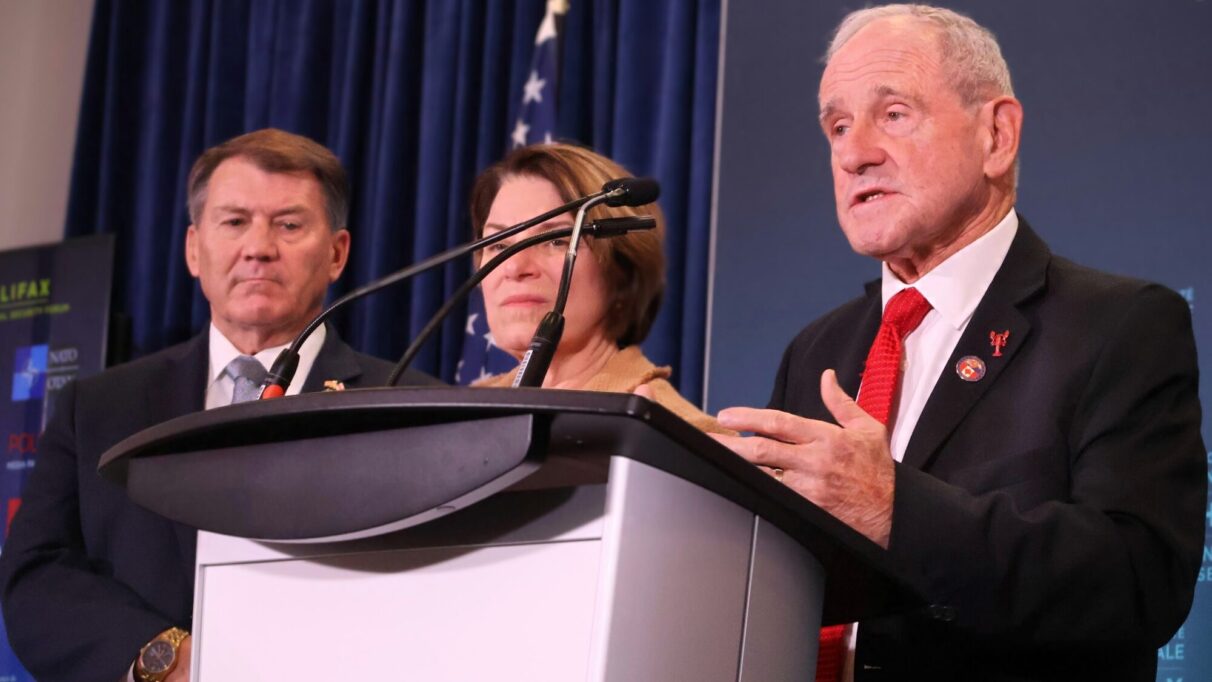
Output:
[{"xmin": 188, "ymin": 128, "xmax": 349, "ymax": 230}]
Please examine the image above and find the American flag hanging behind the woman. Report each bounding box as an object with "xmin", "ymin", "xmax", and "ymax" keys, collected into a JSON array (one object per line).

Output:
[{"xmin": 455, "ymin": 0, "xmax": 568, "ymax": 386}]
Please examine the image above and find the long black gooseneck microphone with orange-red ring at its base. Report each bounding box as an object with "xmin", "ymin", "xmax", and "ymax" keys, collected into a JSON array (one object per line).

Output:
[{"xmin": 261, "ymin": 178, "xmax": 656, "ymax": 400}]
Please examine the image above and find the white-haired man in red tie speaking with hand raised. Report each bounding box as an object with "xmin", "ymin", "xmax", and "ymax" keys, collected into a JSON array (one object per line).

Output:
[{"xmin": 719, "ymin": 6, "xmax": 1207, "ymax": 681}]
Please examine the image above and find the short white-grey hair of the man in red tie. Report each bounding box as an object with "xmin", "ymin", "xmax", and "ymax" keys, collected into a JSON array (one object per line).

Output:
[{"xmin": 825, "ymin": 5, "xmax": 1014, "ymax": 107}]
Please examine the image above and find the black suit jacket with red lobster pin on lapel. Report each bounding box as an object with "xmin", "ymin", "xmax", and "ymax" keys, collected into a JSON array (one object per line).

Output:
[{"xmin": 771, "ymin": 223, "xmax": 1207, "ymax": 682}]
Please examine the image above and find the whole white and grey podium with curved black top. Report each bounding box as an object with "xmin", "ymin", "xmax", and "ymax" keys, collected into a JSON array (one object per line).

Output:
[{"xmin": 101, "ymin": 388, "xmax": 921, "ymax": 682}]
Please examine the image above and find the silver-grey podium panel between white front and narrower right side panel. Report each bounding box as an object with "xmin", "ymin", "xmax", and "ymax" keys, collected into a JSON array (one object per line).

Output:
[{"xmin": 589, "ymin": 458, "xmax": 754, "ymax": 682}]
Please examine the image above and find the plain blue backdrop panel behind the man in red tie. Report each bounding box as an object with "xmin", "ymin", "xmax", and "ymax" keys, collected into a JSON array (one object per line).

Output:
[{"xmin": 707, "ymin": 0, "xmax": 1212, "ymax": 682}]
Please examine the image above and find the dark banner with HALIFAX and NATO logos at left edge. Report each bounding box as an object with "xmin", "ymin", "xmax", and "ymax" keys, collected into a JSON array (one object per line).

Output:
[{"xmin": 0, "ymin": 235, "xmax": 114, "ymax": 682}]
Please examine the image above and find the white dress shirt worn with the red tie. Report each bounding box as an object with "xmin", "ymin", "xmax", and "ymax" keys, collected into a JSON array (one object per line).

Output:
[{"xmin": 842, "ymin": 208, "xmax": 1018, "ymax": 682}]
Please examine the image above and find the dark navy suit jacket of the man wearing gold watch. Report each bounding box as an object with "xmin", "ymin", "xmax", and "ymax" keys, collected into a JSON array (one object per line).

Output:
[{"xmin": 0, "ymin": 328, "xmax": 435, "ymax": 682}]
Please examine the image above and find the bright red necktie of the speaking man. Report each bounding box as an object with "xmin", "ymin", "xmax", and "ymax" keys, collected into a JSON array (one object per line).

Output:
[{"xmin": 817, "ymin": 287, "xmax": 931, "ymax": 682}]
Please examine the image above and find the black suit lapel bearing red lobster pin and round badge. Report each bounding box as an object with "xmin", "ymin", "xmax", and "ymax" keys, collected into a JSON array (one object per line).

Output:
[{"xmin": 903, "ymin": 220, "xmax": 1051, "ymax": 469}]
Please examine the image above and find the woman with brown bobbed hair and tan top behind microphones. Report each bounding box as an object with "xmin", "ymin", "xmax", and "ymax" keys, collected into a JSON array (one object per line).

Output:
[{"xmin": 471, "ymin": 144, "xmax": 726, "ymax": 431}]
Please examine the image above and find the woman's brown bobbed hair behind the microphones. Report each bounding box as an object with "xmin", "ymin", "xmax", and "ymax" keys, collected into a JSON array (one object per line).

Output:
[{"xmin": 471, "ymin": 144, "xmax": 665, "ymax": 348}]
